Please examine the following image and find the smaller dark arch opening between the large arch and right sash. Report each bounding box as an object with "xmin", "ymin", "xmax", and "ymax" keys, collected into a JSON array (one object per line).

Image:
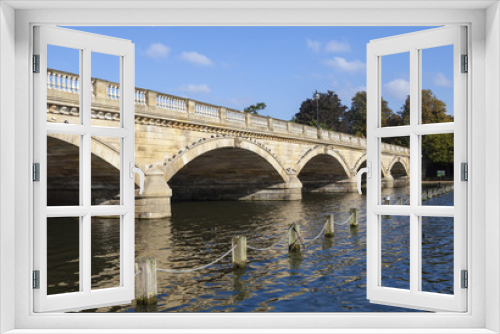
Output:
[{"xmin": 298, "ymin": 154, "xmax": 349, "ymax": 192}]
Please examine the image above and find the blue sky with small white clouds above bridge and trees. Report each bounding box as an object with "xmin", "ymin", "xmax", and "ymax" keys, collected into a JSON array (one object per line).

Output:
[{"xmin": 48, "ymin": 27, "xmax": 453, "ymax": 120}]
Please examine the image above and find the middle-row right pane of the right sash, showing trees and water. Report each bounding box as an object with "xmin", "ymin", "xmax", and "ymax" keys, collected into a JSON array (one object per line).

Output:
[{"xmin": 422, "ymin": 133, "xmax": 455, "ymax": 206}]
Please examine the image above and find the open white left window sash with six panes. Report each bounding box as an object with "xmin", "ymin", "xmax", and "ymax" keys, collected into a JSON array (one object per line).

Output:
[{"xmin": 33, "ymin": 26, "xmax": 135, "ymax": 312}]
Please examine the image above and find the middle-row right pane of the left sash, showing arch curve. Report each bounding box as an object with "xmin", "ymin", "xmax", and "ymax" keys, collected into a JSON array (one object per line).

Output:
[{"xmin": 90, "ymin": 137, "xmax": 121, "ymax": 205}]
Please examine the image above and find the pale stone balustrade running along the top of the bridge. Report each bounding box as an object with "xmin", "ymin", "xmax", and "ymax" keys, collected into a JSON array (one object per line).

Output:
[{"xmin": 47, "ymin": 69, "xmax": 409, "ymax": 155}]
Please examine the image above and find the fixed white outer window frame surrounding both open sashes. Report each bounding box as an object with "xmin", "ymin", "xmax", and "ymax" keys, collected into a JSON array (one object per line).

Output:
[{"xmin": 0, "ymin": 1, "xmax": 500, "ymax": 333}]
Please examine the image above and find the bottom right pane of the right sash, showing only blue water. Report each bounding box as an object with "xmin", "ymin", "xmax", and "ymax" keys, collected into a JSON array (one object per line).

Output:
[{"xmin": 422, "ymin": 217, "xmax": 454, "ymax": 294}]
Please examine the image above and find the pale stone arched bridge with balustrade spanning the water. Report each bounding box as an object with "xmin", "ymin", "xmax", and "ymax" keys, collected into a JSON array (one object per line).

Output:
[{"xmin": 47, "ymin": 70, "xmax": 409, "ymax": 218}]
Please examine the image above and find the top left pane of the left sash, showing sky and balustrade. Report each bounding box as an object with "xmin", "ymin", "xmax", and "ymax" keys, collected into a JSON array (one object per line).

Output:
[{"xmin": 47, "ymin": 45, "xmax": 80, "ymax": 124}]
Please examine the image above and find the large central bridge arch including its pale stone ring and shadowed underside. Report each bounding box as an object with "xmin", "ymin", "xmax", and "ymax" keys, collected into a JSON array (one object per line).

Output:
[{"xmin": 164, "ymin": 138, "xmax": 301, "ymax": 201}]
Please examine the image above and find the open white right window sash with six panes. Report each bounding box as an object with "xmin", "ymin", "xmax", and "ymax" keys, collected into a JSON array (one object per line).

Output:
[{"xmin": 367, "ymin": 26, "xmax": 468, "ymax": 312}]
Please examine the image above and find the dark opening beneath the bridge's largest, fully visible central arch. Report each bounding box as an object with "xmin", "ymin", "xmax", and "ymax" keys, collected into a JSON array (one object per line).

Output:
[{"xmin": 168, "ymin": 147, "xmax": 287, "ymax": 201}]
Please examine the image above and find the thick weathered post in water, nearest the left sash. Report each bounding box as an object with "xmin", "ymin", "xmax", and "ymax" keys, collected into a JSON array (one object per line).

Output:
[{"xmin": 135, "ymin": 257, "xmax": 158, "ymax": 305}]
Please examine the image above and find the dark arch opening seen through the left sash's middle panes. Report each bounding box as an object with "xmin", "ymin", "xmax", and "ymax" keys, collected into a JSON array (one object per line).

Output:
[{"xmin": 47, "ymin": 136, "xmax": 120, "ymax": 206}]
